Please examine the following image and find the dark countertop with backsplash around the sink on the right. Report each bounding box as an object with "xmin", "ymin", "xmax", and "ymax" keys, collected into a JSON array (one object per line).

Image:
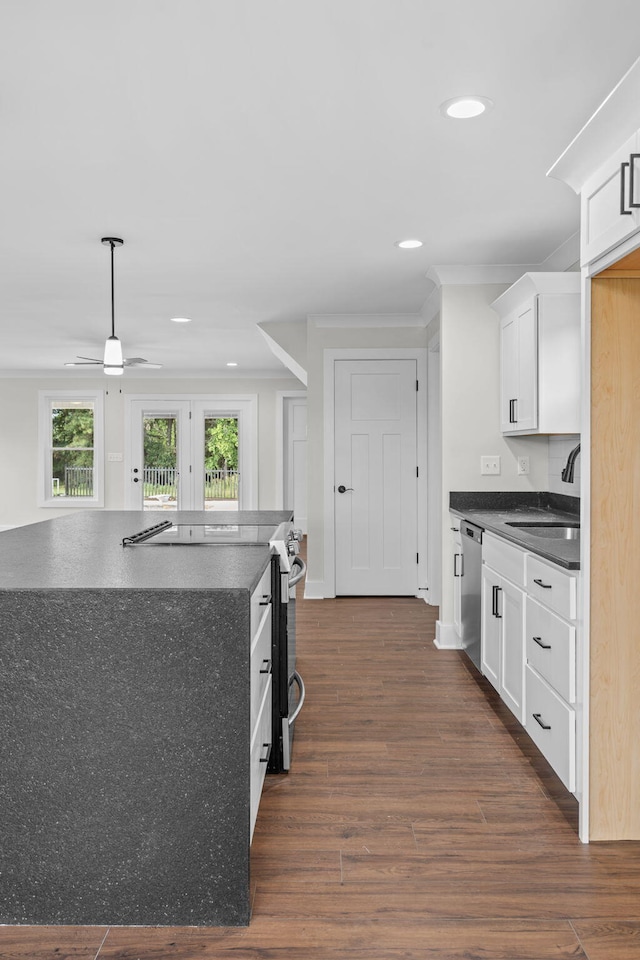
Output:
[{"xmin": 449, "ymin": 491, "xmax": 580, "ymax": 570}]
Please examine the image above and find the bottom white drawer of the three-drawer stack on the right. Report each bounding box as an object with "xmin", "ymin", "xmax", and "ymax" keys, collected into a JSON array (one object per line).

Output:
[{"xmin": 525, "ymin": 665, "xmax": 576, "ymax": 792}]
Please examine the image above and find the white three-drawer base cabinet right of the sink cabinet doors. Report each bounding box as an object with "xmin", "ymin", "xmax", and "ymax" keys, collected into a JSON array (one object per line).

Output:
[{"xmin": 525, "ymin": 555, "xmax": 578, "ymax": 791}]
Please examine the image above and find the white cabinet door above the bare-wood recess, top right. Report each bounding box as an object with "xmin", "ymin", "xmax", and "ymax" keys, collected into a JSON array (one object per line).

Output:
[{"xmin": 580, "ymin": 134, "xmax": 640, "ymax": 264}]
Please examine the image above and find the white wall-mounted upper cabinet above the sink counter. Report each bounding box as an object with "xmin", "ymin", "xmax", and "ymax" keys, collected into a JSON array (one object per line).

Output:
[{"xmin": 492, "ymin": 273, "xmax": 580, "ymax": 436}]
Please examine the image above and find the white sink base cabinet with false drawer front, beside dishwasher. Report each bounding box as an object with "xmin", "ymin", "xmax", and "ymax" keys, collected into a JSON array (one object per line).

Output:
[{"xmin": 481, "ymin": 534, "xmax": 525, "ymax": 723}]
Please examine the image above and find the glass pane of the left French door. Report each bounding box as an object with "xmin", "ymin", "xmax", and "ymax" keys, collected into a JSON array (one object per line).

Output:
[{"xmin": 142, "ymin": 413, "xmax": 179, "ymax": 510}]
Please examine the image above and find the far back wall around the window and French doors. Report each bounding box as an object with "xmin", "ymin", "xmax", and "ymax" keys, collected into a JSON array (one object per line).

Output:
[{"xmin": 0, "ymin": 374, "xmax": 300, "ymax": 528}]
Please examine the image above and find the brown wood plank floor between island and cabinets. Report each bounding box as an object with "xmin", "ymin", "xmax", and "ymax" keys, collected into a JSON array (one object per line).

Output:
[{"xmin": 0, "ymin": 568, "xmax": 640, "ymax": 960}]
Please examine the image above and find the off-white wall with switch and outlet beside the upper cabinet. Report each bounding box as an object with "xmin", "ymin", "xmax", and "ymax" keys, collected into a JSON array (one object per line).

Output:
[{"xmin": 440, "ymin": 284, "xmax": 549, "ymax": 623}]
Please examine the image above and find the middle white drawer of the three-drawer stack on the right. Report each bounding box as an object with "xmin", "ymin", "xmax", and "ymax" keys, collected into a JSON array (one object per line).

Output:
[{"xmin": 526, "ymin": 597, "xmax": 576, "ymax": 703}]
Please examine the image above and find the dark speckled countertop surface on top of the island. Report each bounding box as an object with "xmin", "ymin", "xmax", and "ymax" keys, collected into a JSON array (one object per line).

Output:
[{"xmin": 0, "ymin": 510, "xmax": 291, "ymax": 590}]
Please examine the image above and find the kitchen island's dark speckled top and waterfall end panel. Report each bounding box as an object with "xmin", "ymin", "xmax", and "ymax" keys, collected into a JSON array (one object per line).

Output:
[{"xmin": 0, "ymin": 511, "xmax": 291, "ymax": 926}]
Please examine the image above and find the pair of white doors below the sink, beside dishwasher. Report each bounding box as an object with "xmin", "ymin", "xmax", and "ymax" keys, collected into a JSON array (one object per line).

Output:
[{"xmin": 481, "ymin": 540, "xmax": 524, "ymax": 723}]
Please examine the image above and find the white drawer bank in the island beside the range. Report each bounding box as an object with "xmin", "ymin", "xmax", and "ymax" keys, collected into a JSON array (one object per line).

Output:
[{"xmin": 250, "ymin": 564, "xmax": 273, "ymax": 837}]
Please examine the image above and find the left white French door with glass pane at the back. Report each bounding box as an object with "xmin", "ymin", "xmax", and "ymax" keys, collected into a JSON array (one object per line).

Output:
[{"xmin": 126, "ymin": 400, "xmax": 192, "ymax": 511}]
